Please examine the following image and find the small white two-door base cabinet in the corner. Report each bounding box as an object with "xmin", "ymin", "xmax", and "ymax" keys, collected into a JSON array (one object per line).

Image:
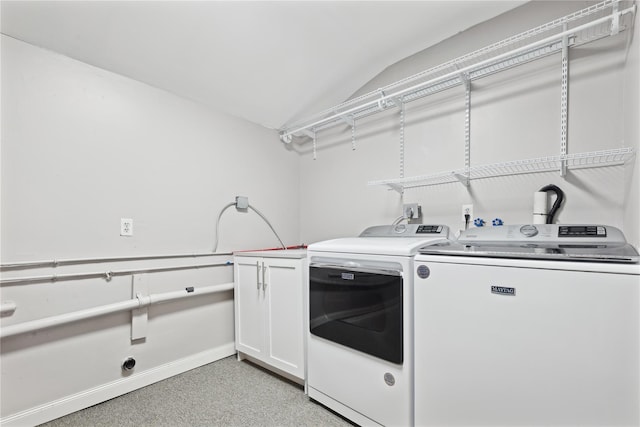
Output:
[{"xmin": 234, "ymin": 251, "xmax": 307, "ymax": 380}]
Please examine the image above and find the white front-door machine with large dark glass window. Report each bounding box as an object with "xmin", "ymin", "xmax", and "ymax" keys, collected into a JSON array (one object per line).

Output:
[{"xmin": 307, "ymin": 224, "xmax": 449, "ymax": 426}]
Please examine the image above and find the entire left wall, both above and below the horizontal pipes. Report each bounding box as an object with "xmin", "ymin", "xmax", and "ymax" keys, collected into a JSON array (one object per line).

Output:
[{"xmin": 1, "ymin": 36, "xmax": 299, "ymax": 424}]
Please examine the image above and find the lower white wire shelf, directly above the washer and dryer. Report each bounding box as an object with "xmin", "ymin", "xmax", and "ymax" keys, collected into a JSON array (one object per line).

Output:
[{"xmin": 368, "ymin": 147, "xmax": 635, "ymax": 192}]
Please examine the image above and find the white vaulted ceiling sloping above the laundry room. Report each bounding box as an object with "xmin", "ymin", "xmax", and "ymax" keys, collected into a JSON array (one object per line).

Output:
[{"xmin": 1, "ymin": 0, "xmax": 524, "ymax": 129}]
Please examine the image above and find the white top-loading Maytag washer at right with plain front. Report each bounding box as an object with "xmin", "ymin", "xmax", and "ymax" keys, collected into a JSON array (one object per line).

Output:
[{"xmin": 414, "ymin": 224, "xmax": 640, "ymax": 426}]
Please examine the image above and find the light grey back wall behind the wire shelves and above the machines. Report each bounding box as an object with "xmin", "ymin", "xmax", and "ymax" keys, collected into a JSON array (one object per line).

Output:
[{"xmin": 300, "ymin": 2, "xmax": 640, "ymax": 245}]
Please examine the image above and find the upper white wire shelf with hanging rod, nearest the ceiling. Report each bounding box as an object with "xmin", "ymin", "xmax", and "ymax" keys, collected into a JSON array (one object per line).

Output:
[{"xmin": 280, "ymin": 0, "xmax": 635, "ymax": 142}]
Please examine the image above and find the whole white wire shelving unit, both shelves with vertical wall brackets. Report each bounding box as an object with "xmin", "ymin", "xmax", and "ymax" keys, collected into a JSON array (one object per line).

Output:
[{"xmin": 280, "ymin": 0, "xmax": 636, "ymax": 193}]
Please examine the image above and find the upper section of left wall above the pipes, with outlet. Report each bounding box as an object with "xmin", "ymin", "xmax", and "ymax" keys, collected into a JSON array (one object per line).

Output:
[{"xmin": 2, "ymin": 36, "xmax": 298, "ymax": 261}]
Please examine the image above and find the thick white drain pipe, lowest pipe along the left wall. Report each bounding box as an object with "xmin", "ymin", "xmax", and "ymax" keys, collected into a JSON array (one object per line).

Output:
[{"xmin": 0, "ymin": 283, "xmax": 233, "ymax": 338}]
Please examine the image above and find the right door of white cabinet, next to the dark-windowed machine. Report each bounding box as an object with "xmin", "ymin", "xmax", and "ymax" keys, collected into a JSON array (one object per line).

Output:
[{"xmin": 265, "ymin": 259, "xmax": 305, "ymax": 378}]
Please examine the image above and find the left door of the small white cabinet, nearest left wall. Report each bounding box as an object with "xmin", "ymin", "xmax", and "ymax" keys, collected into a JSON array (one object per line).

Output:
[{"xmin": 234, "ymin": 257, "xmax": 266, "ymax": 358}]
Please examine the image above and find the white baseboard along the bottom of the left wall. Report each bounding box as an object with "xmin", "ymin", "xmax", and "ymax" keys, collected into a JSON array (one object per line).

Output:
[{"xmin": 0, "ymin": 342, "xmax": 236, "ymax": 427}]
